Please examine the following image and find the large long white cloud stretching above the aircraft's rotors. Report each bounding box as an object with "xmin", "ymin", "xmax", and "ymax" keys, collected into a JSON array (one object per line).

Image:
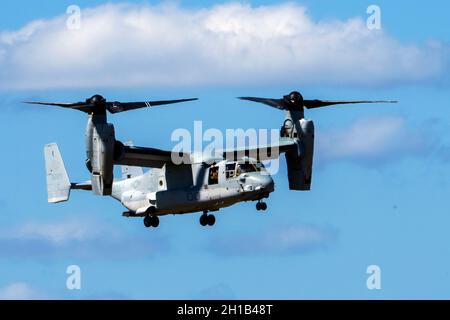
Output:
[{"xmin": 0, "ymin": 3, "xmax": 447, "ymax": 88}]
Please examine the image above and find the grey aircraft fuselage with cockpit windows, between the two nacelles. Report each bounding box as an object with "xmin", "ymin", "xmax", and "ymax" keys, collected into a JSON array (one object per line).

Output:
[{"xmin": 112, "ymin": 160, "xmax": 274, "ymax": 216}]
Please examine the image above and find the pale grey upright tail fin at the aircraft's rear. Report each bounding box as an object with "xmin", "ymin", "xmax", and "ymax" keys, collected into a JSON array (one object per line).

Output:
[{"xmin": 44, "ymin": 143, "xmax": 71, "ymax": 203}]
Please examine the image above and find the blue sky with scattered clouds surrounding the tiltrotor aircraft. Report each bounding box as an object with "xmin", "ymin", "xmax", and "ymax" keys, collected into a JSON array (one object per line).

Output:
[{"xmin": 0, "ymin": 1, "xmax": 450, "ymax": 299}]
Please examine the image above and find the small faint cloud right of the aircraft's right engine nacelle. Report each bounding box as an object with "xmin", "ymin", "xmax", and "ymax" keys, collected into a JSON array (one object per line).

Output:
[{"xmin": 317, "ymin": 117, "xmax": 429, "ymax": 162}]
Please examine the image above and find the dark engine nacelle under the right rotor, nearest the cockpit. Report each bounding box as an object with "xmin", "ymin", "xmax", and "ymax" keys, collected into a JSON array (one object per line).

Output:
[{"xmin": 286, "ymin": 119, "xmax": 314, "ymax": 190}]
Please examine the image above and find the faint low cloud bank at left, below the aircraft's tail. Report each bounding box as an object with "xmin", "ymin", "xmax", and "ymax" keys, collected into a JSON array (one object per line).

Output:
[{"xmin": 0, "ymin": 220, "xmax": 170, "ymax": 259}]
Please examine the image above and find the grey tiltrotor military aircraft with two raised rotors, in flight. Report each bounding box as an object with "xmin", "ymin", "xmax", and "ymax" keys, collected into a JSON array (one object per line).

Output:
[{"xmin": 28, "ymin": 91, "xmax": 395, "ymax": 227}]
